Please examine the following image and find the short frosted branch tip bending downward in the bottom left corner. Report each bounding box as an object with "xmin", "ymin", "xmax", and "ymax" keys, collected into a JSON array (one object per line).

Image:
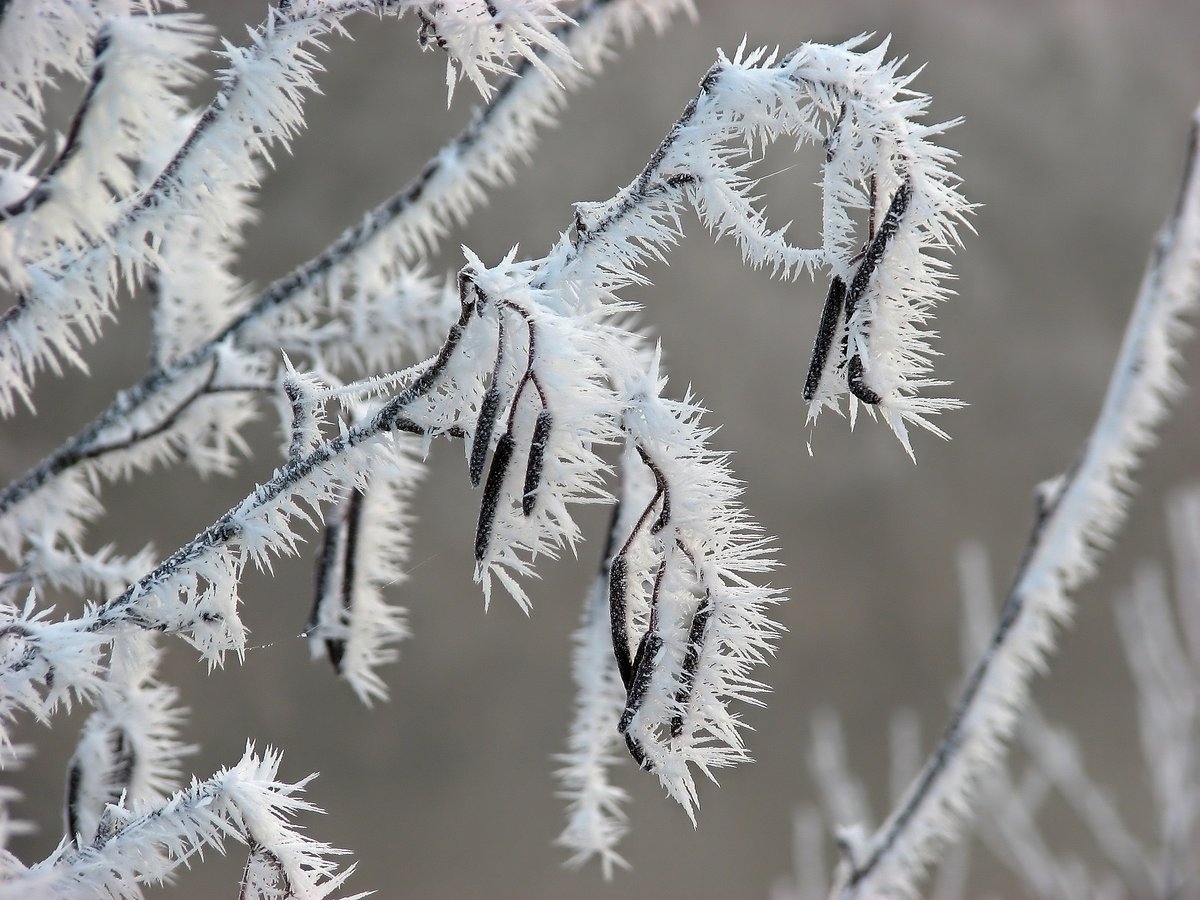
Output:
[{"xmin": 8, "ymin": 744, "xmax": 361, "ymax": 900}]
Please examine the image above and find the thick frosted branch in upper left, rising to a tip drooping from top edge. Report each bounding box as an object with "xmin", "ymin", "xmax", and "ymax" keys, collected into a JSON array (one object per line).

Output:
[{"xmin": 0, "ymin": 0, "xmax": 576, "ymax": 413}]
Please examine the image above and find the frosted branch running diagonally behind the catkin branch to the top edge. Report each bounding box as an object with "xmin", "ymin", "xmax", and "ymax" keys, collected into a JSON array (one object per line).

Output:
[{"xmin": 0, "ymin": 0, "xmax": 686, "ymax": 573}]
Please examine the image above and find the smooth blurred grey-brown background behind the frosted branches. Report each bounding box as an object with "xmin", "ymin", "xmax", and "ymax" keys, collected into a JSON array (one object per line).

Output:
[{"xmin": 0, "ymin": 0, "xmax": 1200, "ymax": 898}]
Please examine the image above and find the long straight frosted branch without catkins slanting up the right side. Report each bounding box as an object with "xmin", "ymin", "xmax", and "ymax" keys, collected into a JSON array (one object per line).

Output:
[{"xmin": 835, "ymin": 103, "xmax": 1200, "ymax": 898}]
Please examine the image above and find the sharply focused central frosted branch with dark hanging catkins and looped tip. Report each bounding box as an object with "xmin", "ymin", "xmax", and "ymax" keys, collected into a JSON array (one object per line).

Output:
[{"xmin": 0, "ymin": 38, "xmax": 967, "ymax": 888}]
